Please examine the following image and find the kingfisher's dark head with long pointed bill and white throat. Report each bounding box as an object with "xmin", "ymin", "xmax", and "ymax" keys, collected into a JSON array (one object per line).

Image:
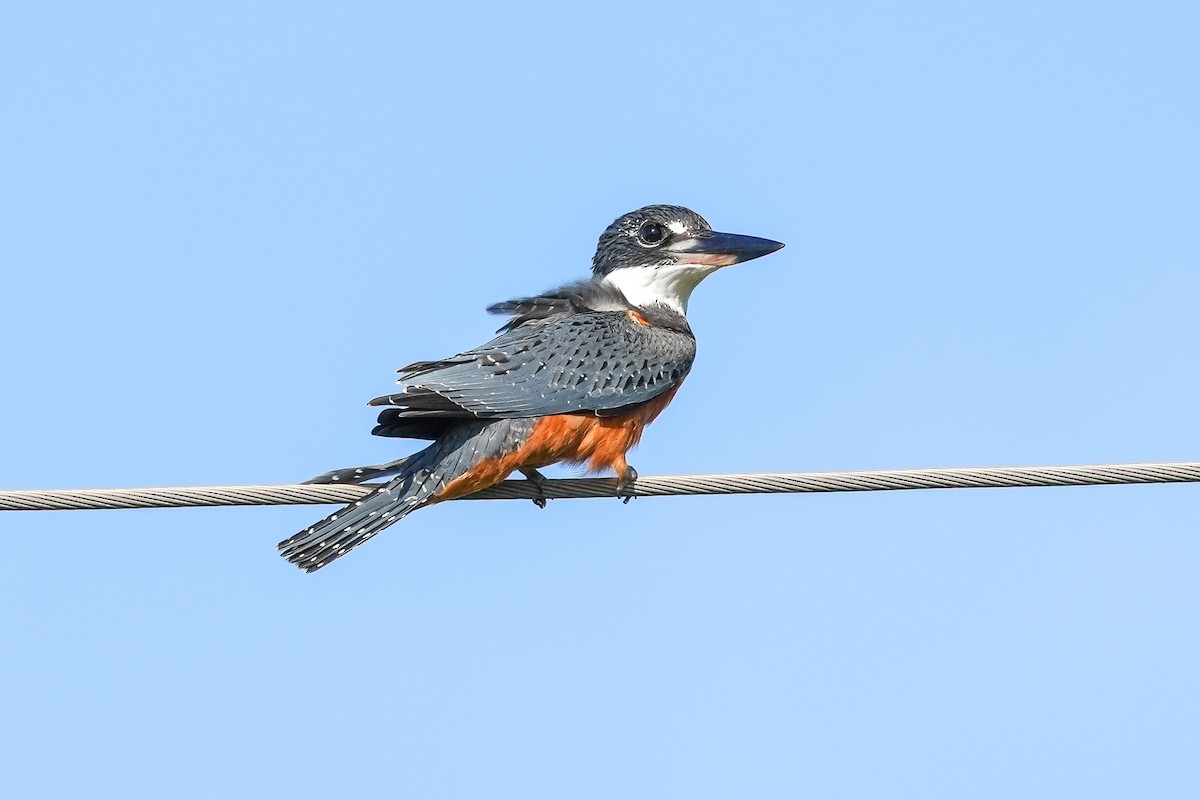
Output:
[{"xmin": 592, "ymin": 205, "xmax": 784, "ymax": 314}]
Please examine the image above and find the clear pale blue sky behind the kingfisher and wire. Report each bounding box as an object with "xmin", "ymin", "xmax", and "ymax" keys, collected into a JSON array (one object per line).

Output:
[{"xmin": 0, "ymin": 2, "xmax": 1200, "ymax": 798}]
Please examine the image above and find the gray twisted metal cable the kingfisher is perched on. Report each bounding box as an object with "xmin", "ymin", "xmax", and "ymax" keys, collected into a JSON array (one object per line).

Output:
[{"xmin": 0, "ymin": 462, "xmax": 1200, "ymax": 511}]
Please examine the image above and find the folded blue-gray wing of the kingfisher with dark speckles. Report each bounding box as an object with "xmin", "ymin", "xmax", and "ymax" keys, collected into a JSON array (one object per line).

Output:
[{"xmin": 371, "ymin": 312, "xmax": 696, "ymax": 422}]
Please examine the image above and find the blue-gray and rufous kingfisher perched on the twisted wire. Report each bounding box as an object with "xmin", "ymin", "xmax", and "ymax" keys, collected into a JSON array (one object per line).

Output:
[{"xmin": 280, "ymin": 205, "xmax": 784, "ymax": 572}]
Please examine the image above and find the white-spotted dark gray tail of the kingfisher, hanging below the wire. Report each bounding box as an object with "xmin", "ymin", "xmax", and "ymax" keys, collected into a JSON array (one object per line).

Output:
[{"xmin": 278, "ymin": 420, "xmax": 526, "ymax": 572}]
